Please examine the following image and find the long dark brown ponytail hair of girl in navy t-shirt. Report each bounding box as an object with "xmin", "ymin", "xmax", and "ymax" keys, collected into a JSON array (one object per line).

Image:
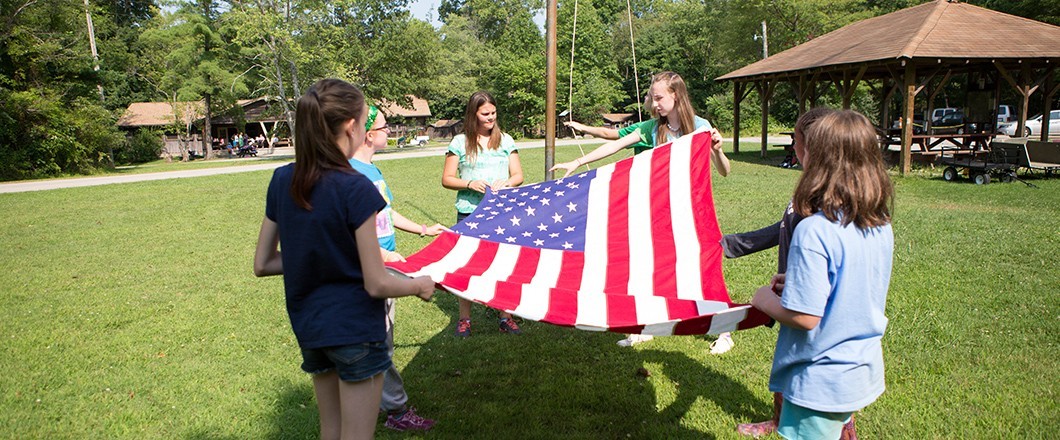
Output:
[{"xmin": 290, "ymin": 80, "xmax": 365, "ymax": 210}]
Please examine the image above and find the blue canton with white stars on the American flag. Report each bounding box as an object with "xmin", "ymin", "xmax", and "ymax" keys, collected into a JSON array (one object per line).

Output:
[{"xmin": 453, "ymin": 170, "xmax": 596, "ymax": 250}]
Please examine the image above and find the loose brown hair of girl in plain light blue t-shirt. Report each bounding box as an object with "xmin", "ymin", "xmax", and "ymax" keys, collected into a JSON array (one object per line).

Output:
[{"xmin": 792, "ymin": 110, "xmax": 895, "ymax": 229}]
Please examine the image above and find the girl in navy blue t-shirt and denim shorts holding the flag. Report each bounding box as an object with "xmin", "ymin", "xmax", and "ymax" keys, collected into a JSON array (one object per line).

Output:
[{"xmin": 254, "ymin": 80, "xmax": 435, "ymax": 438}]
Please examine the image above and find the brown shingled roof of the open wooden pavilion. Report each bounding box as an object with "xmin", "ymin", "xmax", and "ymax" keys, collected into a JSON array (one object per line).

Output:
[{"xmin": 718, "ymin": 0, "xmax": 1060, "ymax": 81}]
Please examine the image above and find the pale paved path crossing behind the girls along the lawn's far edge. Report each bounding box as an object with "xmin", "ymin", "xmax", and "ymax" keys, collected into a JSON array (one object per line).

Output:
[{"xmin": 0, "ymin": 137, "xmax": 790, "ymax": 194}]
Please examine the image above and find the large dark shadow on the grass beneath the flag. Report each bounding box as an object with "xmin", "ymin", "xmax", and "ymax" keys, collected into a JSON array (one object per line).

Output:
[{"xmin": 385, "ymin": 294, "xmax": 770, "ymax": 439}]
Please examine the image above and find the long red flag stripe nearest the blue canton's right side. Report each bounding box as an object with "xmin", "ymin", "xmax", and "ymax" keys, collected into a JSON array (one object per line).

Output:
[{"xmin": 606, "ymin": 159, "xmax": 633, "ymax": 294}]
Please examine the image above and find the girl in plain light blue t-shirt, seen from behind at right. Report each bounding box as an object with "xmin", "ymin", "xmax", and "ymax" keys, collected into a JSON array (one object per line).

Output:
[{"xmin": 752, "ymin": 110, "xmax": 895, "ymax": 439}]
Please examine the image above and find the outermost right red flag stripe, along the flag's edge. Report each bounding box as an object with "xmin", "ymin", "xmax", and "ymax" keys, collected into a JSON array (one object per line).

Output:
[{"xmin": 689, "ymin": 131, "xmax": 729, "ymax": 301}]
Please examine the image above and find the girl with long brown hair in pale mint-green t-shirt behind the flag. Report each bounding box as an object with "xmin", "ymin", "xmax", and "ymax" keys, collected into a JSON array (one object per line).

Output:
[{"xmin": 442, "ymin": 91, "xmax": 523, "ymax": 337}]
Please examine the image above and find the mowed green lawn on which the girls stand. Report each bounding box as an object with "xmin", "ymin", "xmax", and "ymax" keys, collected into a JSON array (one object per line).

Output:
[{"xmin": 0, "ymin": 146, "xmax": 1060, "ymax": 439}]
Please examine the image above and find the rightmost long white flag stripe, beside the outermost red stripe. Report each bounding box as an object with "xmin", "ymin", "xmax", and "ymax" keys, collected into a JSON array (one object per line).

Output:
[{"xmin": 670, "ymin": 132, "xmax": 709, "ymax": 299}]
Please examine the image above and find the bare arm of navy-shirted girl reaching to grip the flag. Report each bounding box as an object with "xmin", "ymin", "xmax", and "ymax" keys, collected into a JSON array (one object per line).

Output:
[{"xmin": 354, "ymin": 215, "xmax": 435, "ymax": 301}]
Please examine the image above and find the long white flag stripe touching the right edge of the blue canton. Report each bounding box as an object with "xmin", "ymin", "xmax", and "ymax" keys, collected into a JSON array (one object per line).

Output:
[{"xmin": 579, "ymin": 164, "xmax": 615, "ymax": 292}]
